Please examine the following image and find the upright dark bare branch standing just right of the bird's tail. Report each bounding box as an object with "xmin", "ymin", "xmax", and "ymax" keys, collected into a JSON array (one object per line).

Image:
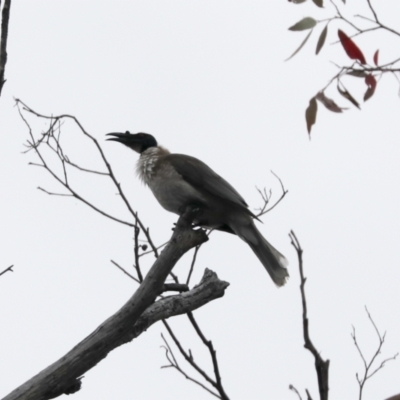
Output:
[{"xmin": 289, "ymin": 231, "xmax": 329, "ymax": 400}]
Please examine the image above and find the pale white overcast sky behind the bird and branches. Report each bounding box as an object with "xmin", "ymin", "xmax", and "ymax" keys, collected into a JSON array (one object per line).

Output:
[{"xmin": 0, "ymin": 0, "xmax": 400, "ymax": 400}]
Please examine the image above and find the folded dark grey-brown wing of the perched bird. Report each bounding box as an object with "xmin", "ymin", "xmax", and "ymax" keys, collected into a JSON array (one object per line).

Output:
[{"xmin": 165, "ymin": 154, "xmax": 253, "ymax": 215}]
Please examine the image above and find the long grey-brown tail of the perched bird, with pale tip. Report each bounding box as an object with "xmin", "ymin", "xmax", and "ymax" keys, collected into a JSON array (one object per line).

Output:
[{"xmin": 231, "ymin": 221, "xmax": 289, "ymax": 286}]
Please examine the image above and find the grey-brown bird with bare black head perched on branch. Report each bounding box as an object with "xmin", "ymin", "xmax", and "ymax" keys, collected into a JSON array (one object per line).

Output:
[{"xmin": 107, "ymin": 131, "xmax": 289, "ymax": 287}]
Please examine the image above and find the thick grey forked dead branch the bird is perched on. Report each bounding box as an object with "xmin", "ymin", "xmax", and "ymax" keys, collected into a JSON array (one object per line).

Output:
[{"xmin": 3, "ymin": 211, "xmax": 216, "ymax": 400}]
